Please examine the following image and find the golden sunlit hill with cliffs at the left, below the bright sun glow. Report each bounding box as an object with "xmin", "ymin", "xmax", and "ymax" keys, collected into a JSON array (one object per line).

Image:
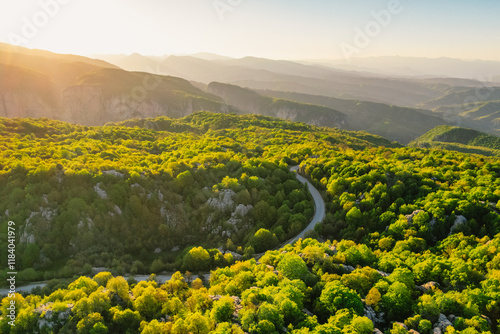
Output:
[{"xmin": 0, "ymin": 44, "xmax": 237, "ymax": 125}]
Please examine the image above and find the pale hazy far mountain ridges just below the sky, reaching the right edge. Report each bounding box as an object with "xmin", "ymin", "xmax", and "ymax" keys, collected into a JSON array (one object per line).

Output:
[{"xmin": 96, "ymin": 54, "xmax": 500, "ymax": 107}]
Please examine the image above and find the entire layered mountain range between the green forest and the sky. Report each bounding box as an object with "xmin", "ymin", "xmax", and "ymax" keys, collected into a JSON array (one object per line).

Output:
[{"xmin": 0, "ymin": 44, "xmax": 500, "ymax": 144}]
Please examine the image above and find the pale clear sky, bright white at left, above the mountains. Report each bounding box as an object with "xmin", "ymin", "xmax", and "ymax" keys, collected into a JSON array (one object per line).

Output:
[{"xmin": 0, "ymin": 0, "xmax": 500, "ymax": 60}]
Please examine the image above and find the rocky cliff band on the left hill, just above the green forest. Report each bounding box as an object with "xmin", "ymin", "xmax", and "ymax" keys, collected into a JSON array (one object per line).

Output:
[{"xmin": 0, "ymin": 85, "xmax": 233, "ymax": 126}]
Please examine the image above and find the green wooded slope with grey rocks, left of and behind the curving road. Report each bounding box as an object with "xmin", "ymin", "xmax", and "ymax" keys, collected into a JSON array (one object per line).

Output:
[{"xmin": 0, "ymin": 112, "xmax": 397, "ymax": 281}]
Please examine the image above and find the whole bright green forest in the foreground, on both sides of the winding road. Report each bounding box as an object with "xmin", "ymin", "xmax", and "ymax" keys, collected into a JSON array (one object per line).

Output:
[{"xmin": 0, "ymin": 113, "xmax": 500, "ymax": 334}]
